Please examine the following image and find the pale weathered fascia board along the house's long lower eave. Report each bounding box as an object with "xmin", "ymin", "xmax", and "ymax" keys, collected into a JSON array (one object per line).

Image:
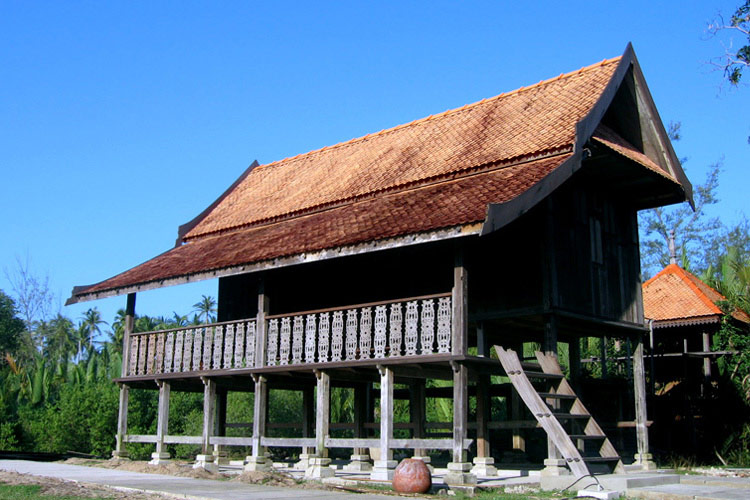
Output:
[{"xmin": 65, "ymin": 222, "xmax": 482, "ymax": 306}]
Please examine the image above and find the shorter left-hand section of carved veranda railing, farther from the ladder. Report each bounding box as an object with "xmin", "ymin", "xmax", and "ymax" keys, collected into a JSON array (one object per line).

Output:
[{"xmin": 127, "ymin": 319, "xmax": 255, "ymax": 375}]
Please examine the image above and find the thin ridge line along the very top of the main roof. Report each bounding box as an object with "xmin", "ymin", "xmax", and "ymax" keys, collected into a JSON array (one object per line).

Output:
[{"xmin": 254, "ymin": 56, "xmax": 622, "ymax": 171}]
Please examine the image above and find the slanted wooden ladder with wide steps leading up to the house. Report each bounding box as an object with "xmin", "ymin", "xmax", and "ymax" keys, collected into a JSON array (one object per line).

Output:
[{"xmin": 495, "ymin": 346, "xmax": 625, "ymax": 477}]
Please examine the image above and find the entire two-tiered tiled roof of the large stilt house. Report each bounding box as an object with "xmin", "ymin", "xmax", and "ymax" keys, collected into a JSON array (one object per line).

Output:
[{"xmin": 68, "ymin": 47, "xmax": 689, "ymax": 303}]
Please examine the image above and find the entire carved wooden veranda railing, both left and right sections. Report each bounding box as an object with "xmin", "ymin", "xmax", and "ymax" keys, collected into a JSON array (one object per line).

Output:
[{"xmin": 127, "ymin": 293, "xmax": 453, "ymax": 376}]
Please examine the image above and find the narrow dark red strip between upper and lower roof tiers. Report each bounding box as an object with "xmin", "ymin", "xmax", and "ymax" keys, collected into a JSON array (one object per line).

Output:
[{"xmin": 183, "ymin": 146, "xmax": 572, "ymax": 243}]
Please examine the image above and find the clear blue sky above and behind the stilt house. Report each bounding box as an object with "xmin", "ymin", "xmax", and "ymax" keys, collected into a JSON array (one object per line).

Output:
[{"xmin": 0, "ymin": 0, "xmax": 750, "ymax": 340}]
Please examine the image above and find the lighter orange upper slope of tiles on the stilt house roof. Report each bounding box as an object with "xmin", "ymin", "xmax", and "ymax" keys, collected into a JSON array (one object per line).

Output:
[{"xmin": 184, "ymin": 58, "xmax": 620, "ymax": 241}]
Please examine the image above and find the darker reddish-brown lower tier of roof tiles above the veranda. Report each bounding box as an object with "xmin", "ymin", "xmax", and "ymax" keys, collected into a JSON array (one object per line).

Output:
[{"xmin": 79, "ymin": 154, "xmax": 570, "ymax": 293}]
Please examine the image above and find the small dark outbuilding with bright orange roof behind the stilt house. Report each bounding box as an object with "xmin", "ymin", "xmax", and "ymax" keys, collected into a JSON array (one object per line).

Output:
[{"xmin": 643, "ymin": 258, "xmax": 750, "ymax": 457}]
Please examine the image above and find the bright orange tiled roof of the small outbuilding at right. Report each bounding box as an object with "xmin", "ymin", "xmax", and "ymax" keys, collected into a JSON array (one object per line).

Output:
[{"xmin": 643, "ymin": 264, "xmax": 750, "ymax": 324}]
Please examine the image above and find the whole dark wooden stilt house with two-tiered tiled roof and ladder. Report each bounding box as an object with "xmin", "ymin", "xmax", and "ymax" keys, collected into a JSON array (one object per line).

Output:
[{"xmin": 69, "ymin": 47, "xmax": 691, "ymax": 483}]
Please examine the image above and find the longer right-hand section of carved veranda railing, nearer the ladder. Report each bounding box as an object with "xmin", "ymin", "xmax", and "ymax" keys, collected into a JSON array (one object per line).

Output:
[{"xmin": 266, "ymin": 293, "xmax": 453, "ymax": 366}]
